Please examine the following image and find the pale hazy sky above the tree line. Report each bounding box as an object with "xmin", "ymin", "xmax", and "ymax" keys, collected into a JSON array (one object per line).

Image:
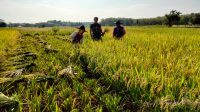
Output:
[{"xmin": 0, "ymin": 0, "xmax": 200, "ymax": 23}]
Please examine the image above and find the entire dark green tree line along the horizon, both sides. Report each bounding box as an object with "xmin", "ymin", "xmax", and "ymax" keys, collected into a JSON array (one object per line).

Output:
[{"xmin": 0, "ymin": 10, "xmax": 200, "ymax": 28}]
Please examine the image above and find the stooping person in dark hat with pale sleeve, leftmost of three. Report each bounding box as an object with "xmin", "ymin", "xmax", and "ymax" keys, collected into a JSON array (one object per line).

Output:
[{"xmin": 70, "ymin": 25, "xmax": 87, "ymax": 44}]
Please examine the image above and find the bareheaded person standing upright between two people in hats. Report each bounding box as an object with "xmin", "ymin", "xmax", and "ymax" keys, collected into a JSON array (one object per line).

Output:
[{"xmin": 90, "ymin": 17, "xmax": 106, "ymax": 41}]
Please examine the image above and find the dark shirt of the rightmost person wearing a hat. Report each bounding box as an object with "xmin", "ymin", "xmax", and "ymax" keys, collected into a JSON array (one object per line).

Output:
[{"xmin": 113, "ymin": 26, "xmax": 126, "ymax": 38}]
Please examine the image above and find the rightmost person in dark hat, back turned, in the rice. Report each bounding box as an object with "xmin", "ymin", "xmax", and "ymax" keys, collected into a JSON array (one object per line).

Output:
[{"xmin": 113, "ymin": 21, "xmax": 126, "ymax": 39}]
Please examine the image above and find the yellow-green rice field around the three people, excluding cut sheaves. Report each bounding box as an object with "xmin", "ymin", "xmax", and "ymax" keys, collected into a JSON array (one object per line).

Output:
[{"xmin": 0, "ymin": 27, "xmax": 200, "ymax": 112}]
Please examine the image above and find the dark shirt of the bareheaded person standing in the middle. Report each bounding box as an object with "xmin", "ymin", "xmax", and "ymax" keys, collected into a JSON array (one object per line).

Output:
[{"xmin": 90, "ymin": 23, "xmax": 102, "ymax": 39}]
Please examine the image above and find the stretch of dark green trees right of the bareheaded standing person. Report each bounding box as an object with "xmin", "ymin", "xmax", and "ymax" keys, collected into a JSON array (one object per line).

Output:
[{"xmin": 101, "ymin": 10, "xmax": 200, "ymax": 27}]
